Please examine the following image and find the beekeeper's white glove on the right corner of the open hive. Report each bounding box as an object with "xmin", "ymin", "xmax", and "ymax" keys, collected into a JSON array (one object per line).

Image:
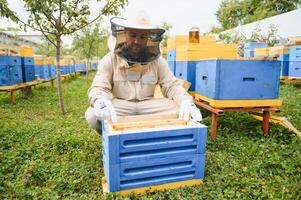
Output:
[{"xmin": 179, "ymin": 100, "xmax": 203, "ymax": 122}]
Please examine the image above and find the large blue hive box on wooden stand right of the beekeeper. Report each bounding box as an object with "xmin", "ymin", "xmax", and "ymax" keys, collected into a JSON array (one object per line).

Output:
[{"xmin": 196, "ymin": 59, "xmax": 280, "ymax": 100}]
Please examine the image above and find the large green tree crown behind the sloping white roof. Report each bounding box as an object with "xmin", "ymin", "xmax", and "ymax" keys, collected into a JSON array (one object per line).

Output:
[{"xmin": 213, "ymin": 0, "xmax": 301, "ymax": 31}]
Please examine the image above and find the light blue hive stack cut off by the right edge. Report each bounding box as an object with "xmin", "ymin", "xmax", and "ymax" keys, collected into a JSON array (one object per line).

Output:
[{"xmin": 288, "ymin": 46, "xmax": 301, "ymax": 79}]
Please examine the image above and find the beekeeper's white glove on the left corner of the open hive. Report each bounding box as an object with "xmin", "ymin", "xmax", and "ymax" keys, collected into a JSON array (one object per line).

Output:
[{"xmin": 94, "ymin": 99, "xmax": 117, "ymax": 123}]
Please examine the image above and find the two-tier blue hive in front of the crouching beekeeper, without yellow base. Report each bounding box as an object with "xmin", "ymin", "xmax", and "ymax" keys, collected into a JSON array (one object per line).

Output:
[{"xmin": 102, "ymin": 117, "xmax": 207, "ymax": 192}]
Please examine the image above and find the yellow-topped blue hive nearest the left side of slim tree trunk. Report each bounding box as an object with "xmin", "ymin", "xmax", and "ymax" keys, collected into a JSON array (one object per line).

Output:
[{"xmin": 34, "ymin": 56, "xmax": 50, "ymax": 80}]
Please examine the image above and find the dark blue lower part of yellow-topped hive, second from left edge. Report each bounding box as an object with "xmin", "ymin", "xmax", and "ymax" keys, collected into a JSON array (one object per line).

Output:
[{"xmin": 21, "ymin": 57, "xmax": 36, "ymax": 83}]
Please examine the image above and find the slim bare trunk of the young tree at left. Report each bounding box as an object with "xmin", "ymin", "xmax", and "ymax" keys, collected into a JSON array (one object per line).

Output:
[{"xmin": 56, "ymin": 35, "xmax": 65, "ymax": 115}]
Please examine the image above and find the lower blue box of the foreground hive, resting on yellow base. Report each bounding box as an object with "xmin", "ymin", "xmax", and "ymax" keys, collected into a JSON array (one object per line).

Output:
[{"xmin": 105, "ymin": 154, "xmax": 205, "ymax": 192}]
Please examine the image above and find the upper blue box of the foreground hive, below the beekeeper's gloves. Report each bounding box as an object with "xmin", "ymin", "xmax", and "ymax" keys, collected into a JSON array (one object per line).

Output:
[{"xmin": 102, "ymin": 122, "xmax": 207, "ymax": 164}]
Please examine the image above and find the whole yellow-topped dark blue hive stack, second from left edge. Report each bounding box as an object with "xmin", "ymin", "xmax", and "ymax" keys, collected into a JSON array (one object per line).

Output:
[{"xmin": 19, "ymin": 47, "xmax": 36, "ymax": 83}]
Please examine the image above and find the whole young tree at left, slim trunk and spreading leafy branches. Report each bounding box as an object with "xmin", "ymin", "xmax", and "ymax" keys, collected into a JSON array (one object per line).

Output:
[{"xmin": 0, "ymin": 0, "xmax": 127, "ymax": 115}]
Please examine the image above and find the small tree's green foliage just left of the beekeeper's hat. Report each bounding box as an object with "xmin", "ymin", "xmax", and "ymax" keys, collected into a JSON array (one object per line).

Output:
[{"xmin": 72, "ymin": 23, "xmax": 109, "ymax": 60}]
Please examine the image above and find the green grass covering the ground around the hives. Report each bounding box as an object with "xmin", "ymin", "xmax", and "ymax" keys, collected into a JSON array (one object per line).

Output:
[{"xmin": 0, "ymin": 76, "xmax": 301, "ymax": 200}]
